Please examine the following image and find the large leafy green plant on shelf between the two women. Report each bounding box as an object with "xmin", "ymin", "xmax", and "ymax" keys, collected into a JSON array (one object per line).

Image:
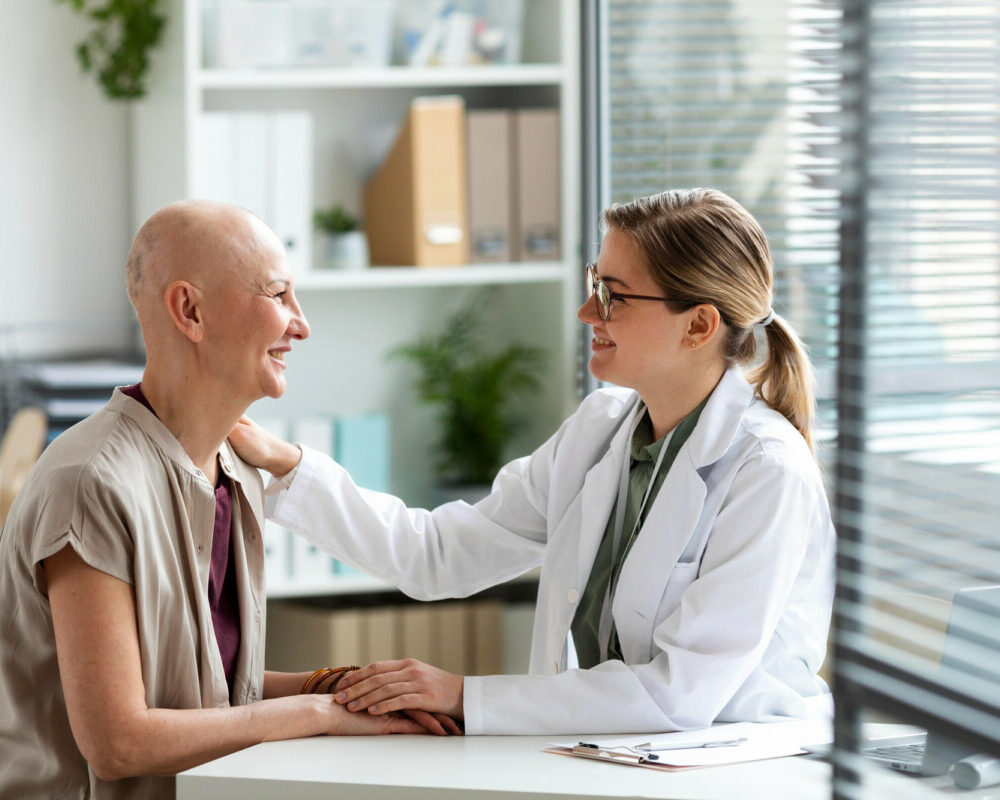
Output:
[{"xmin": 389, "ymin": 290, "xmax": 544, "ymax": 501}]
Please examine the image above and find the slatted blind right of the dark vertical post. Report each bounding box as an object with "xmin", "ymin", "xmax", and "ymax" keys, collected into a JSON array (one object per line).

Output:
[{"xmin": 837, "ymin": 0, "xmax": 1000, "ymax": 796}]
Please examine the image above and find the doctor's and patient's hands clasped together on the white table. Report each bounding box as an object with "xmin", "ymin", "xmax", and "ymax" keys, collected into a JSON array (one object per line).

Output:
[{"xmin": 334, "ymin": 658, "xmax": 464, "ymax": 736}]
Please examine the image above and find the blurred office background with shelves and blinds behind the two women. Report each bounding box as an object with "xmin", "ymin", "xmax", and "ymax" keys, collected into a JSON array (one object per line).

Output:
[{"xmin": 0, "ymin": 0, "xmax": 1000, "ymax": 796}]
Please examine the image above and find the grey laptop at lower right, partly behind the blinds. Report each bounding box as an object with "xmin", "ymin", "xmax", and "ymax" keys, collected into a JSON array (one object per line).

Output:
[{"xmin": 808, "ymin": 586, "xmax": 1000, "ymax": 775}]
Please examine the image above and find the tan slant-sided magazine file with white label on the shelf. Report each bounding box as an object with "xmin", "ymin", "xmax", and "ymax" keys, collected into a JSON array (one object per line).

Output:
[{"xmin": 365, "ymin": 96, "xmax": 469, "ymax": 266}]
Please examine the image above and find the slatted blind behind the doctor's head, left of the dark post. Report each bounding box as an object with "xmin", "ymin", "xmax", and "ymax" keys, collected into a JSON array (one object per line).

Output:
[{"xmin": 604, "ymin": 0, "xmax": 840, "ymax": 418}]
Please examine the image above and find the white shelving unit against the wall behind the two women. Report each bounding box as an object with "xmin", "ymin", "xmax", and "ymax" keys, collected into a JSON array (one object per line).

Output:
[{"xmin": 132, "ymin": 0, "xmax": 581, "ymax": 594}]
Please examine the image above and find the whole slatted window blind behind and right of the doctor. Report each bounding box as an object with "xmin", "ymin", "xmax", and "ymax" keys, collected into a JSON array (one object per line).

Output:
[{"xmin": 584, "ymin": 0, "xmax": 1000, "ymax": 797}]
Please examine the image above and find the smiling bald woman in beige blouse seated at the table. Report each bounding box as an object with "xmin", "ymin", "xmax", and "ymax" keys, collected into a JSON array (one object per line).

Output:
[{"xmin": 0, "ymin": 202, "xmax": 430, "ymax": 800}]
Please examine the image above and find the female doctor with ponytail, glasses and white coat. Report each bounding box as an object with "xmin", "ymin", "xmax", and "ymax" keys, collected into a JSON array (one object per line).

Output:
[{"xmin": 231, "ymin": 189, "xmax": 834, "ymax": 734}]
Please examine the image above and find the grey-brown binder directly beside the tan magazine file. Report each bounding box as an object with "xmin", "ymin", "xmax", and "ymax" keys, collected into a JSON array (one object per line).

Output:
[{"xmin": 466, "ymin": 109, "xmax": 514, "ymax": 263}]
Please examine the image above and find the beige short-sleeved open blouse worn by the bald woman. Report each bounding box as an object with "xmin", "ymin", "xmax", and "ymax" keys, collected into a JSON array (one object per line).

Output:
[{"xmin": 0, "ymin": 390, "xmax": 265, "ymax": 800}]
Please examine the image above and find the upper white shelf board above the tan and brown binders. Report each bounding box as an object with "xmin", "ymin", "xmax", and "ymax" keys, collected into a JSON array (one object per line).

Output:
[{"xmin": 197, "ymin": 64, "xmax": 566, "ymax": 90}]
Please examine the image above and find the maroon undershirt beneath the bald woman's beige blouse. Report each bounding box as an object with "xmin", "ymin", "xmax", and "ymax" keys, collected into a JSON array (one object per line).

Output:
[{"xmin": 122, "ymin": 383, "xmax": 240, "ymax": 698}]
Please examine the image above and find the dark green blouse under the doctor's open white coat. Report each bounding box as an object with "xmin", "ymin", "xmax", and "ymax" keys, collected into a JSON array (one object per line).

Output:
[{"xmin": 571, "ymin": 399, "xmax": 708, "ymax": 669}]
